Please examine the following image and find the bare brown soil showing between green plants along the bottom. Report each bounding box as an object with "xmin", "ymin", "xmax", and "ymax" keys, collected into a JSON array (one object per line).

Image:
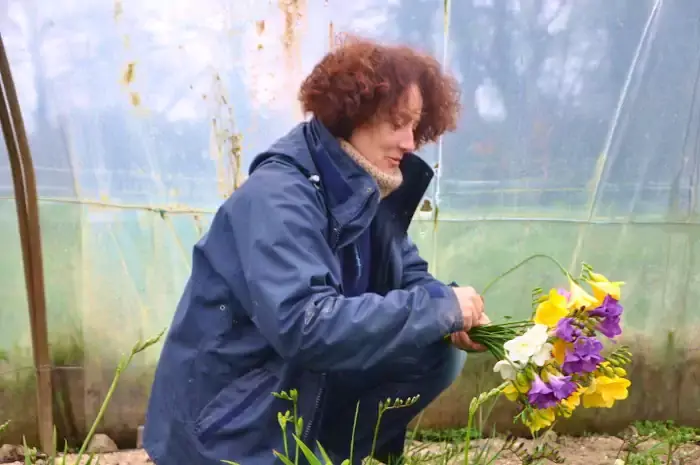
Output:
[{"xmin": 4, "ymin": 436, "xmax": 700, "ymax": 465}]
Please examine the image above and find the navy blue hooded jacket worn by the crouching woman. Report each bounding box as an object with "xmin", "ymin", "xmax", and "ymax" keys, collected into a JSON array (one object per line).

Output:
[{"xmin": 144, "ymin": 119, "xmax": 463, "ymax": 465}]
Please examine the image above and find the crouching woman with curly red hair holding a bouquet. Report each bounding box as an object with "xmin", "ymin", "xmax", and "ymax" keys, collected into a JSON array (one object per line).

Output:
[{"xmin": 144, "ymin": 36, "xmax": 485, "ymax": 465}]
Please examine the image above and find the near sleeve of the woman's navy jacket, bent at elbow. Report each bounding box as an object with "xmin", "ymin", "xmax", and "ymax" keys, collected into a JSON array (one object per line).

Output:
[{"xmin": 197, "ymin": 161, "xmax": 463, "ymax": 371}]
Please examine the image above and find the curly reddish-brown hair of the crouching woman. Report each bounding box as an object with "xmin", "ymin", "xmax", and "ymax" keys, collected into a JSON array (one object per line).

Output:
[{"xmin": 299, "ymin": 37, "xmax": 460, "ymax": 147}]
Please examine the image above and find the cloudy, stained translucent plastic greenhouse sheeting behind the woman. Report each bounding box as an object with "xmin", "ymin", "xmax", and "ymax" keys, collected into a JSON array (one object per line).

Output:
[{"xmin": 0, "ymin": 0, "xmax": 700, "ymax": 442}]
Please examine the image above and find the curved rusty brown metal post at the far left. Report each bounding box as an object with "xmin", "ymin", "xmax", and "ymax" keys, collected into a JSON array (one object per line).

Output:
[{"xmin": 0, "ymin": 34, "xmax": 56, "ymax": 455}]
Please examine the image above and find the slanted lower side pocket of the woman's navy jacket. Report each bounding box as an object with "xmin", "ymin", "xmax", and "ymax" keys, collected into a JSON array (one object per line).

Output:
[{"xmin": 194, "ymin": 368, "xmax": 277, "ymax": 444}]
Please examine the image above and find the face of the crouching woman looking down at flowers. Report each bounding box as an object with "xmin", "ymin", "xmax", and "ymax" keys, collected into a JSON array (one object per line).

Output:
[{"xmin": 349, "ymin": 85, "xmax": 423, "ymax": 173}]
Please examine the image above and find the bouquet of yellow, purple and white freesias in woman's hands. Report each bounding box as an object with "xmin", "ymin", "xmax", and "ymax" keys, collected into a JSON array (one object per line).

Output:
[{"xmin": 469, "ymin": 256, "xmax": 631, "ymax": 433}]
